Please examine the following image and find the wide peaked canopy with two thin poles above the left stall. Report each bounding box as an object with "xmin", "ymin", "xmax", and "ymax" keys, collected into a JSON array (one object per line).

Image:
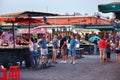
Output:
[{"xmin": 0, "ymin": 11, "xmax": 59, "ymax": 48}]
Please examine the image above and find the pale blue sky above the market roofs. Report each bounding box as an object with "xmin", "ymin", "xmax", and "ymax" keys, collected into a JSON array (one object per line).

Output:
[{"xmin": 0, "ymin": 0, "xmax": 119, "ymax": 16}]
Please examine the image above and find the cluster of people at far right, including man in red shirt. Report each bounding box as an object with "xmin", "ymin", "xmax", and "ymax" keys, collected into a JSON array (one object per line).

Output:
[{"xmin": 98, "ymin": 34, "xmax": 120, "ymax": 64}]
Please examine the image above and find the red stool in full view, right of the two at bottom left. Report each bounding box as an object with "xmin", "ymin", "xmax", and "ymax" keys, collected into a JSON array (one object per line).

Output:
[{"xmin": 8, "ymin": 66, "xmax": 20, "ymax": 80}]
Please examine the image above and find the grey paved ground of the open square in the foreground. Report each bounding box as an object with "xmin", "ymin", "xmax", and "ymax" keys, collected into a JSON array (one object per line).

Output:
[{"xmin": 20, "ymin": 54, "xmax": 120, "ymax": 80}]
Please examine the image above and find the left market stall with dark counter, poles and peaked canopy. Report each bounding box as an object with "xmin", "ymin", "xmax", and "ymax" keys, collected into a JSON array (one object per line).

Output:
[{"xmin": 0, "ymin": 11, "xmax": 57, "ymax": 66}]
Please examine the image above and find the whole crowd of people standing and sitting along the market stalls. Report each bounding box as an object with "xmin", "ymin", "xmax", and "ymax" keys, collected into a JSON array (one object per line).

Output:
[{"xmin": 0, "ymin": 29, "xmax": 120, "ymax": 67}]
